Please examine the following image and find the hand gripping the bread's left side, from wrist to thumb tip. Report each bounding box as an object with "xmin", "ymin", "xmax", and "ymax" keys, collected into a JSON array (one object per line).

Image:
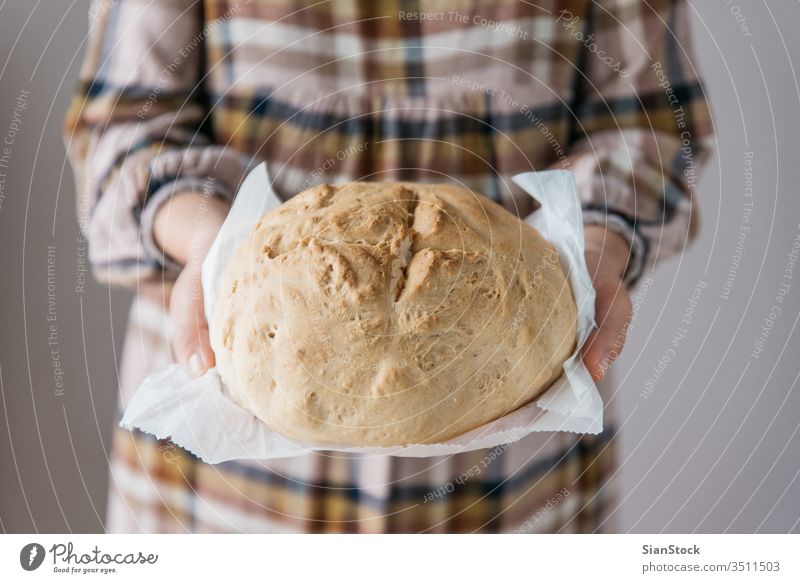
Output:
[{"xmin": 154, "ymin": 192, "xmax": 228, "ymax": 378}]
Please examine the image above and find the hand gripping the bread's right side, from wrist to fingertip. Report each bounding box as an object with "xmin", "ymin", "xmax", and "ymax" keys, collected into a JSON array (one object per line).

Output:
[{"xmin": 583, "ymin": 225, "xmax": 632, "ymax": 381}]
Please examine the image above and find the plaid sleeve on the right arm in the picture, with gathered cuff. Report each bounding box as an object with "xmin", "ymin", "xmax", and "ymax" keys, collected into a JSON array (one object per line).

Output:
[{"xmin": 561, "ymin": 0, "xmax": 713, "ymax": 285}]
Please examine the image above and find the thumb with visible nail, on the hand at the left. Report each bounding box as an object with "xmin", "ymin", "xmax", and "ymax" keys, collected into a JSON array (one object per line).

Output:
[{"xmin": 170, "ymin": 265, "xmax": 214, "ymax": 378}]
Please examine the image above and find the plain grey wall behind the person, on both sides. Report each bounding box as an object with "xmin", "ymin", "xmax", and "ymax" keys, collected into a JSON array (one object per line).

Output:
[{"xmin": 0, "ymin": 0, "xmax": 800, "ymax": 532}]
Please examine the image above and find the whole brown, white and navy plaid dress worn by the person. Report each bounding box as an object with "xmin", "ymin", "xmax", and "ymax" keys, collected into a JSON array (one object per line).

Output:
[{"xmin": 65, "ymin": 0, "xmax": 713, "ymax": 532}]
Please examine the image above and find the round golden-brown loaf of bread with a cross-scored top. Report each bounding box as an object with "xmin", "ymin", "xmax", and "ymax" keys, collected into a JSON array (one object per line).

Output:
[{"xmin": 211, "ymin": 182, "xmax": 576, "ymax": 447}]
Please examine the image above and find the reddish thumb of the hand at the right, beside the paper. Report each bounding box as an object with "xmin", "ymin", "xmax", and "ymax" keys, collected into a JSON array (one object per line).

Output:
[{"xmin": 583, "ymin": 282, "xmax": 631, "ymax": 381}]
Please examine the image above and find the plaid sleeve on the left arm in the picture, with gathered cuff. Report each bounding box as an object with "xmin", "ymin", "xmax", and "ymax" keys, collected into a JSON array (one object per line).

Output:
[{"xmin": 64, "ymin": 0, "xmax": 246, "ymax": 285}]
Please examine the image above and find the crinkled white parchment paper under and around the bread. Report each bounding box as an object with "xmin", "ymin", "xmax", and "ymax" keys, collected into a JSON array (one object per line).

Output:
[{"xmin": 120, "ymin": 164, "xmax": 603, "ymax": 464}]
